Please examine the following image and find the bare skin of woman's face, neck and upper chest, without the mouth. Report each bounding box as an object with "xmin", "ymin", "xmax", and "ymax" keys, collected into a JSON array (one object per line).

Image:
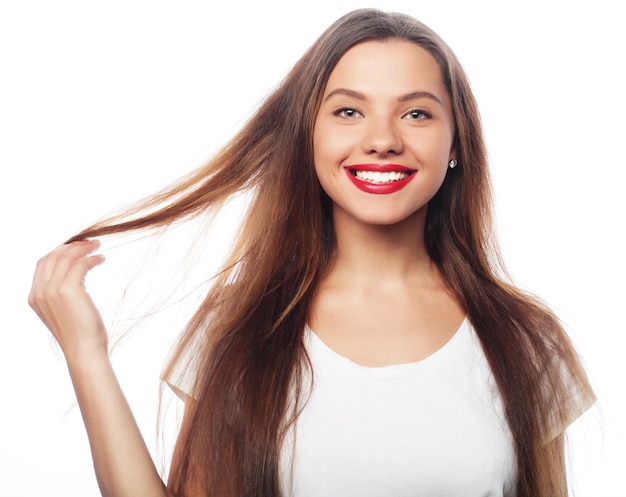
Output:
[{"xmin": 309, "ymin": 40, "xmax": 464, "ymax": 366}]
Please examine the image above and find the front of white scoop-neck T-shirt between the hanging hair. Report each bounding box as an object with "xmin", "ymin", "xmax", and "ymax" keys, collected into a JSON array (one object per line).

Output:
[{"xmin": 281, "ymin": 319, "xmax": 516, "ymax": 497}]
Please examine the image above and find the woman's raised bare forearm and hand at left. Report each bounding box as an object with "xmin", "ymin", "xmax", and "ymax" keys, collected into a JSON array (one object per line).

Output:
[{"xmin": 29, "ymin": 241, "xmax": 171, "ymax": 497}]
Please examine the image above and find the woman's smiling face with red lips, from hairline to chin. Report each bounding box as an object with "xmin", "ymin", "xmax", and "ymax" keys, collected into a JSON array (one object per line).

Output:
[{"xmin": 313, "ymin": 40, "xmax": 455, "ymax": 225}]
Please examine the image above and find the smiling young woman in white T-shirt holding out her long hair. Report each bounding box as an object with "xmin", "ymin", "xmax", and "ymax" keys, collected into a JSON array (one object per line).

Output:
[{"xmin": 30, "ymin": 10, "xmax": 594, "ymax": 497}]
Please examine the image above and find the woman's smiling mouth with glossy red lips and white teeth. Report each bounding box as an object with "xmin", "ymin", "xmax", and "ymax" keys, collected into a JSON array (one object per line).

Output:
[{"xmin": 344, "ymin": 164, "xmax": 417, "ymax": 195}]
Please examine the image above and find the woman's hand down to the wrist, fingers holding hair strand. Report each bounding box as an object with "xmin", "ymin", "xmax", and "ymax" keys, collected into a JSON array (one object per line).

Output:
[{"xmin": 28, "ymin": 240, "xmax": 108, "ymax": 363}]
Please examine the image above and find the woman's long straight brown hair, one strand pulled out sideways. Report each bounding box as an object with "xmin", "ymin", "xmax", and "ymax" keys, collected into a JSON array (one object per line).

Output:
[{"xmin": 67, "ymin": 9, "xmax": 593, "ymax": 497}]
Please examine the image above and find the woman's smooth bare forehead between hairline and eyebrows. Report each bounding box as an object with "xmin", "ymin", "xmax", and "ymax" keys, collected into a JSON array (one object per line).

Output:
[{"xmin": 324, "ymin": 40, "xmax": 448, "ymax": 101}]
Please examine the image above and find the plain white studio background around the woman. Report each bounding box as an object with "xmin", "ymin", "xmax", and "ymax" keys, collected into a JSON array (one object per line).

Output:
[{"xmin": 0, "ymin": 0, "xmax": 626, "ymax": 497}]
